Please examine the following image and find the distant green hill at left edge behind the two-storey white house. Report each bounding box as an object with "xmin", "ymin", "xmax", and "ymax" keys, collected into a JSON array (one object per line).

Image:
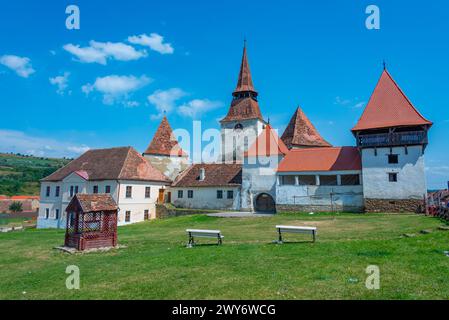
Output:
[{"xmin": 0, "ymin": 153, "xmax": 71, "ymax": 196}]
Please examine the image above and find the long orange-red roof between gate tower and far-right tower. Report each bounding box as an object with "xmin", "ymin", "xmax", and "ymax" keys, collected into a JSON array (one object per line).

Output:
[{"xmin": 278, "ymin": 147, "xmax": 362, "ymax": 172}]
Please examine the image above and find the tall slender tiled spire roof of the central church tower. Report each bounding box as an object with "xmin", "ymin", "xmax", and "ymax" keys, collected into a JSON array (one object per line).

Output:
[{"xmin": 220, "ymin": 45, "xmax": 263, "ymax": 122}]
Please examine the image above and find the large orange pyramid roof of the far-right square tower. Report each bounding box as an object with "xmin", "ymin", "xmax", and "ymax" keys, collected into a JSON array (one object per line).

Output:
[{"xmin": 352, "ymin": 70, "xmax": 432, "ymax": 132}]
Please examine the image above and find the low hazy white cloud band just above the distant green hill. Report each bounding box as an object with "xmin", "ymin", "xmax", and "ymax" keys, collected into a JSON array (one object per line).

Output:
[{"xmin": 0, "ymin": 129, "xmax": 89, "ymax": 157}]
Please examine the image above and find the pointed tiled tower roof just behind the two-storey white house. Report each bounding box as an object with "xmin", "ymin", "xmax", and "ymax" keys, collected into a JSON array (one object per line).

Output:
[{"xmin": 144, "ymin": 116, "xmax": 187, "ymax": 156}]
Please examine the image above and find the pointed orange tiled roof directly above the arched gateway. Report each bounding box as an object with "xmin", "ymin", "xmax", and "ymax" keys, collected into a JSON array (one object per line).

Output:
[{"xmin": 245, "ymin": 124, "xmax": 288, "ymax": 157}]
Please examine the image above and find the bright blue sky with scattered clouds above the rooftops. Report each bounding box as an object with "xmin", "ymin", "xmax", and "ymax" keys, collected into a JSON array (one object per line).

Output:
[{"xmin": 0, "ymin": 0, "xmax": 449, "ymax": 188}]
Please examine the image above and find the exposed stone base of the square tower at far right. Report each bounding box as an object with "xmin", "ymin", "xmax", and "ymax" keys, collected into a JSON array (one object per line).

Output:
[{"xmin": 365, "ymin": 199, "xmax": 425, "ymax": 213}]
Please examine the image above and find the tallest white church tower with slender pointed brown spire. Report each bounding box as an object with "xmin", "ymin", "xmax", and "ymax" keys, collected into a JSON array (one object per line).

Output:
[{"xmin": 220, "ymin": 42, "xmax": 266, "ymax": 163}]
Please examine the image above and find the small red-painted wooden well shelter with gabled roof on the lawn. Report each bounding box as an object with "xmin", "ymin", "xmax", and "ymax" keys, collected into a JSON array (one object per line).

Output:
[{"xmin": 64, "ymin": 194, "xmax": 118, "ymax": 251}]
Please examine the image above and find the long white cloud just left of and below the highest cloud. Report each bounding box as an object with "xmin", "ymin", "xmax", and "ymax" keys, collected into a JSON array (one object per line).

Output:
[{"xmin": 63, "ymin": 40, "xmax": 147, "ymax": 65}]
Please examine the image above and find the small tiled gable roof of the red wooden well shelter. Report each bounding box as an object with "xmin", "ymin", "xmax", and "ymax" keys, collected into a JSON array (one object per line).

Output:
[{"xmin": 66, "ymin": 194, "xmax": 118, "ymax": 212}]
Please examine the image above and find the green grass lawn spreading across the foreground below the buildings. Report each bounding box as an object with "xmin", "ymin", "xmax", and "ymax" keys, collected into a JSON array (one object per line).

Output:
[{"xmin": 0, "ymin": 214, "xmax": 449, "ymax": 299}]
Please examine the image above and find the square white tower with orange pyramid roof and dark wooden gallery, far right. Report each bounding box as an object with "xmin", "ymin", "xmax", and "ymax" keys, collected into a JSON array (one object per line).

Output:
[{"xmin": 352, "ymin": 69, "xmax": 432, "ymax": 212}]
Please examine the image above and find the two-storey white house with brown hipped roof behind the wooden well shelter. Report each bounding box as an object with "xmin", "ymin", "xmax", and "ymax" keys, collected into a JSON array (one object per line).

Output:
[{"xmin": 37, "ymin": 147, "xmax": 171, "ymax": 228}]
